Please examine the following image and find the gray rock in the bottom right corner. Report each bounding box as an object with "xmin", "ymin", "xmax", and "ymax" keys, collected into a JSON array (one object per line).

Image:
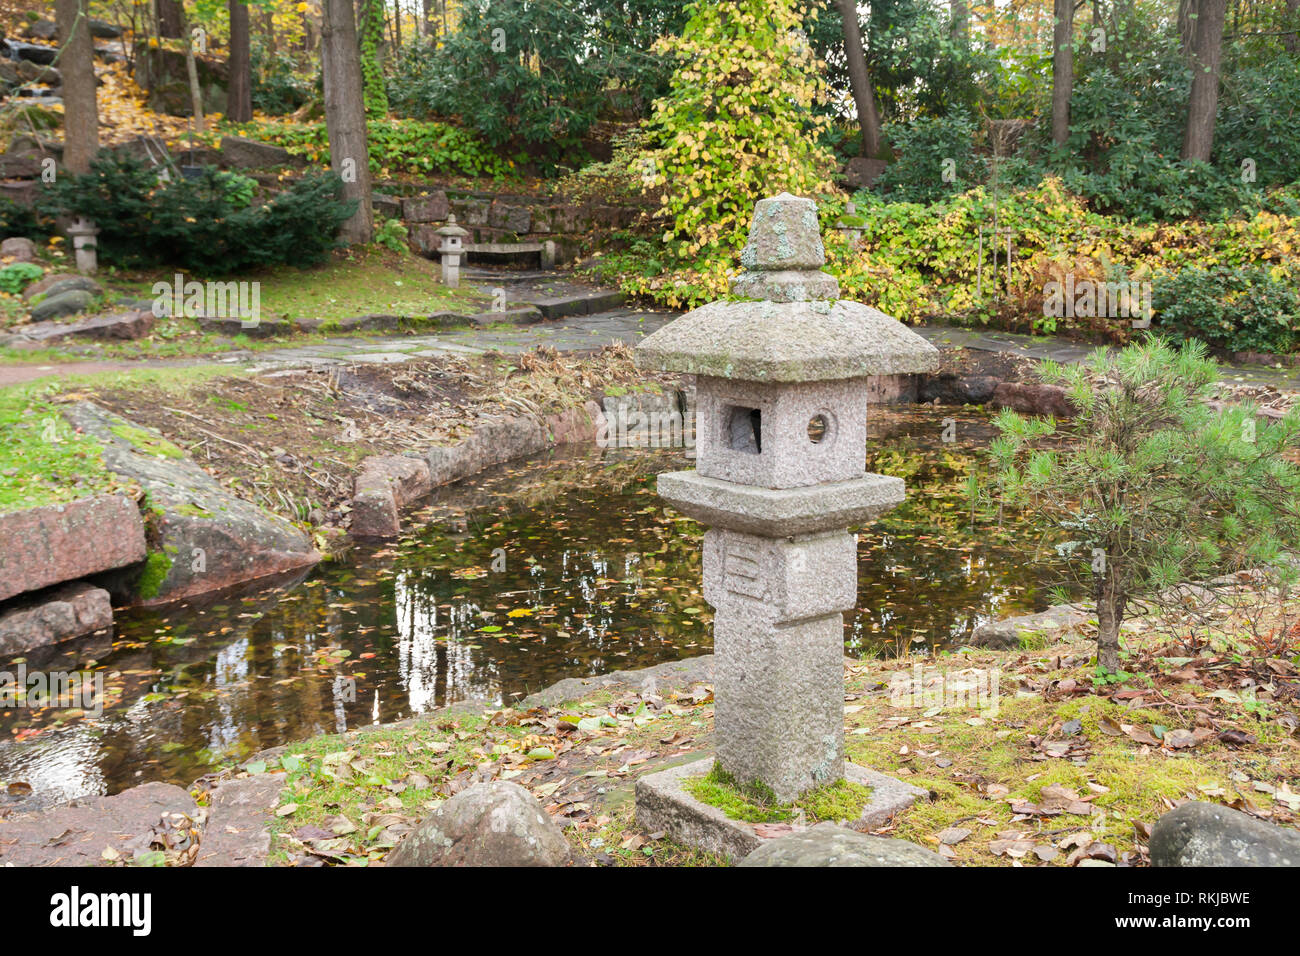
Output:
[{"xmin": 1148, "ymin": 803, "xmax": 1300, "ymax": 866}]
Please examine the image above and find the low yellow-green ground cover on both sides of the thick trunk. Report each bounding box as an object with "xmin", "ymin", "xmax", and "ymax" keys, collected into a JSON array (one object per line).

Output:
[{"xmin": 243, "ymin": 120, "xmax": 512, "ymax": 177}]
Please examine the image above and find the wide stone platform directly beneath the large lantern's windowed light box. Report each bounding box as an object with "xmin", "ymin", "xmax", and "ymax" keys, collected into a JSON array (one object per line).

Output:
[{"xmin": 657, "ymin": 471, "xmax": 905, "ymax": 537}]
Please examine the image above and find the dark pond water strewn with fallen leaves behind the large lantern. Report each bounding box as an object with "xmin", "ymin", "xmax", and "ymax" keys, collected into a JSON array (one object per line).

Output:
[{"xmin": 0, "ymin": 407, "xmax": 1066, "ymax": 809}]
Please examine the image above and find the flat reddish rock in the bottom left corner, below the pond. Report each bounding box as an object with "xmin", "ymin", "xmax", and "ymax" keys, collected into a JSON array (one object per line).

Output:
[{"xmin": 0, "ymin": 783, "xmax": 196, "ymax": 866}]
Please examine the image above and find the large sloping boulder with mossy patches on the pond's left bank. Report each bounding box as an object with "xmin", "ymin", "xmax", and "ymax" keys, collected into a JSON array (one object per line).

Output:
[{"xmin": 64, "ymin": 402, "xmax": 320, "ymax": 605}]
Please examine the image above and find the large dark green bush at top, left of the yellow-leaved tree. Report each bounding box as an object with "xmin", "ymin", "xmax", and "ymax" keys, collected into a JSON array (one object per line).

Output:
[{"xmin": 390, "ymin": 0, "xmax": 684, "ymax": 168}]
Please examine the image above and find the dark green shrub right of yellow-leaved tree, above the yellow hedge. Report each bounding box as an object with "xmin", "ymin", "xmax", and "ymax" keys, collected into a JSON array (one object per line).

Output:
[{"xmin": 878, "ymin": 114, "xmax": 987, "ymax": 203}]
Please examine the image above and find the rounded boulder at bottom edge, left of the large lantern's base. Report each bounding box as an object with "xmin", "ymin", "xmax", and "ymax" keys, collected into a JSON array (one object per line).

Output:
[{"xmin": 386, "ymin": 780, "xmax": 569, "ymax": 866}]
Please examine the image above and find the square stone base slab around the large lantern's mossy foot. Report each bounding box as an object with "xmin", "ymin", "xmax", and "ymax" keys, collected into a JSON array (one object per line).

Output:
[{"xmin": 636, "ymin": 759, "xmax": 926, "ymax": 861}]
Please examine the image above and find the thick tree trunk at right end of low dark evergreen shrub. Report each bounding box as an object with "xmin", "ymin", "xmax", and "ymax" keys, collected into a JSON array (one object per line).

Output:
[{"xmin": 321, "ymin": 0, "xmax": 374, "ymax": 243}]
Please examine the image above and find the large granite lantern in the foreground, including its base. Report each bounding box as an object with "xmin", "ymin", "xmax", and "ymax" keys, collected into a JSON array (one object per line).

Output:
[{"xmin": 636, "ymin": 193, "xmax": 939, "ymax": 856}]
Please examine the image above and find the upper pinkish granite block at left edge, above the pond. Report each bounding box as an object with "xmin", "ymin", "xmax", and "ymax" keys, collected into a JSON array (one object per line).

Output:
[{"xmin": 0, "ymin": 494, "xmax": 146, "ymax": 601}]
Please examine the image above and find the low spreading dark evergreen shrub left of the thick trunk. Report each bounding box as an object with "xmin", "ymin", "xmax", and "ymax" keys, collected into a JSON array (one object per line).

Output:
[{"xmin": 39, "ymin": 152, "xmax": 356, "ymax": 274}]
